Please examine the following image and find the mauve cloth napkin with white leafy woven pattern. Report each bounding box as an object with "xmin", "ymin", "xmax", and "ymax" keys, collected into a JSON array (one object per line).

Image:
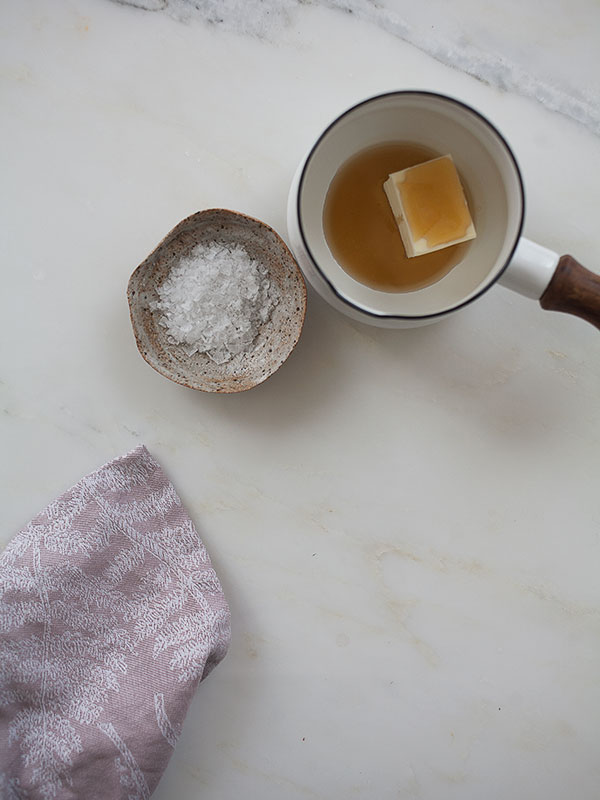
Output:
[{"xmin": 0, "ymin": 447, "xmax": 230, "ymax": 800}]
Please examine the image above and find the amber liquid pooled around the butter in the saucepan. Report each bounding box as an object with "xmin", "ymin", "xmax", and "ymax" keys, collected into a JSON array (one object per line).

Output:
[{"xmin": 323, "ymin": 142, "xmax": 470, "ymax": 292}]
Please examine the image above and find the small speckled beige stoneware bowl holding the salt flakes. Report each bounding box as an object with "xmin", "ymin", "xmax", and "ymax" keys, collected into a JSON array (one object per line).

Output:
[{"xmin": 127, "ymin": 208, "xmax": 306, "ymax": 393}]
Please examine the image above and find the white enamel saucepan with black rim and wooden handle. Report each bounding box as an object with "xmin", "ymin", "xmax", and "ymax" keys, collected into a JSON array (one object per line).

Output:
[{"xmin": 288, "ymin": 91, "xmax": 600, "ymax": 328}]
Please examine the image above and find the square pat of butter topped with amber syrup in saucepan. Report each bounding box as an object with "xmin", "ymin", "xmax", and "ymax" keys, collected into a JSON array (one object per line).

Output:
[{"xmin": 383, "ymin": 155, "xmax": 477, "ymax": 258}]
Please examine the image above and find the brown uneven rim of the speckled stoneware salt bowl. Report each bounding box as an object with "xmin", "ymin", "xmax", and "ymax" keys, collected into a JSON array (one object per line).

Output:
[{"xmin": 127, "ymin": 207, "xmax": 307, "ymax": 394}]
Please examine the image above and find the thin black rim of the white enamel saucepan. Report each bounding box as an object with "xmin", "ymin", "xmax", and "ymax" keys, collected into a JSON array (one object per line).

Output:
[{"xmin": 296, "ymin": 90, "xmax": 525, "ymax": 320}]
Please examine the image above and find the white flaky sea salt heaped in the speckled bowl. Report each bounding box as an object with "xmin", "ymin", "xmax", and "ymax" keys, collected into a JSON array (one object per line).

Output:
[{"xmin": 150, "ymin": 242, "xmax": 278, "ymax": 364}]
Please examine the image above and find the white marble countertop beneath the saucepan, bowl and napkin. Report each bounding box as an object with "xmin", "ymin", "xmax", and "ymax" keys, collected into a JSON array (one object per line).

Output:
[{"xmin": 0, "ymin": 0, "xmax": 600, "ymax": 800}]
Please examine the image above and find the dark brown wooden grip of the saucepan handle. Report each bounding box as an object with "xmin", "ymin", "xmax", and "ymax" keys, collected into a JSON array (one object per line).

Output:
[{"xmin": 540, "ymin": 256, "xmax": 600, "ymax": 329}]
